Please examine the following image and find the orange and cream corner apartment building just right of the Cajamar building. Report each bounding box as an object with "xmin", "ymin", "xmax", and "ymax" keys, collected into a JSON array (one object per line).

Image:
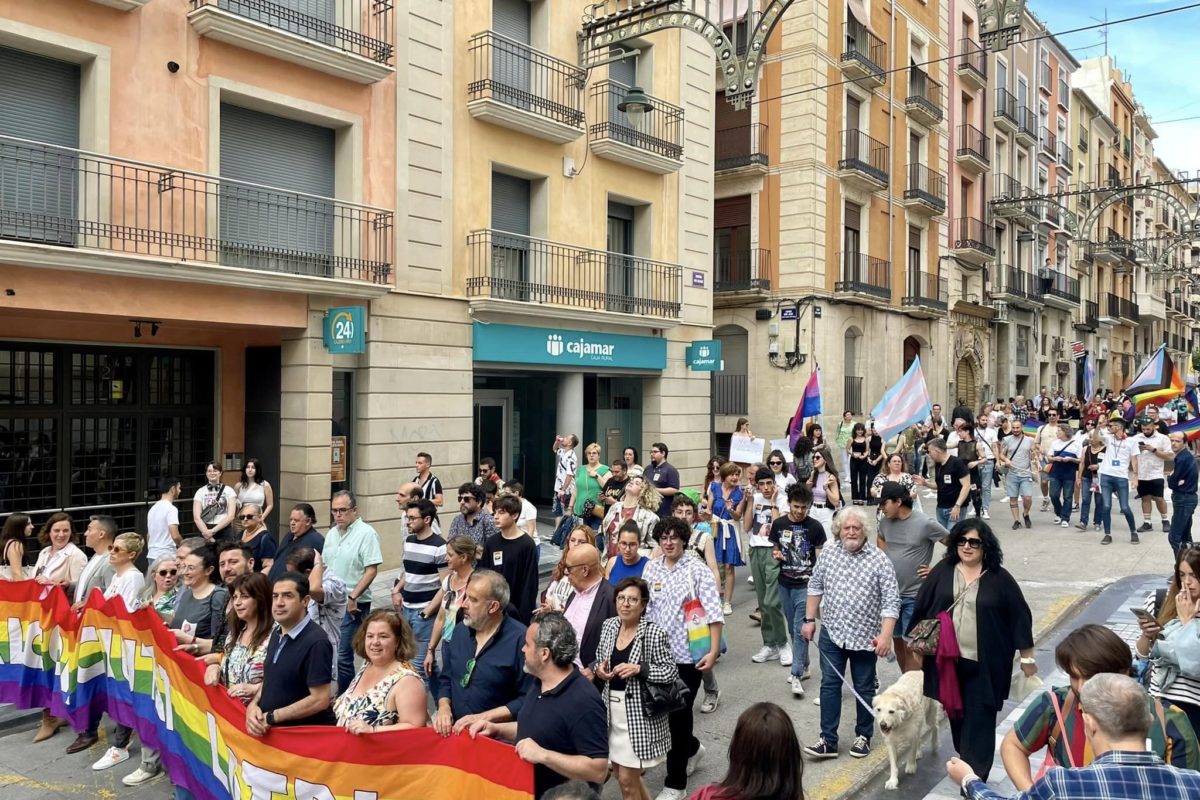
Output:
[{"xmin": 713, "ymin": 0, "xmax": 950, "ymax": 434}]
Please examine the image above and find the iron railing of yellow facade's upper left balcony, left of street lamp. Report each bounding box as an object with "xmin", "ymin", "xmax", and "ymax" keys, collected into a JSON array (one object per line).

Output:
[{"xmin": 467, "ymin": 31, "xmax": 587, "ymax": 127}]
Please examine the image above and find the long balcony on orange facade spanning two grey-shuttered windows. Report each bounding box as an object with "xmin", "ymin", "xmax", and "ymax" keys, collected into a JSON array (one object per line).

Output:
[{"xmin": 0, "ymin": 137, "xmax": 395, "ymax": 299}]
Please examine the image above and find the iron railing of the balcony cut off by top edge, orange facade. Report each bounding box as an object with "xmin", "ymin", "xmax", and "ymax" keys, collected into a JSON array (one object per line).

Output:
[{"xmin": 191, "ymin": 0, "xmax": 395, "ymax": 64}]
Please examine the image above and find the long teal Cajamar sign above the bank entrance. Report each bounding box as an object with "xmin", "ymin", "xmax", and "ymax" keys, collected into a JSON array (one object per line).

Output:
[{"xmin": 472, "ymin": 321, "xmax": 667, "ymax": 371}]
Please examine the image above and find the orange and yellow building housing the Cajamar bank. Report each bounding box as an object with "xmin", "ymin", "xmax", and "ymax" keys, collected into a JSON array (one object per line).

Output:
[{"xmin": 0, "ymin": 0, "xmax": 713, "ymax": 564}]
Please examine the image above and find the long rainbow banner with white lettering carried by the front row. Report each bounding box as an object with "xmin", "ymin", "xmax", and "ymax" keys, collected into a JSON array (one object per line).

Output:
[{"xmin": 0, "ymin": 581, "xmax": 533, "ymax": 800}]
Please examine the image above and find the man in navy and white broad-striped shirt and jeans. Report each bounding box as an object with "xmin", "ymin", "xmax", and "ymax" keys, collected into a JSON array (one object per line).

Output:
[{"xmin": 391, "ymin": 499, "xmax": 446, "ymax": 678}]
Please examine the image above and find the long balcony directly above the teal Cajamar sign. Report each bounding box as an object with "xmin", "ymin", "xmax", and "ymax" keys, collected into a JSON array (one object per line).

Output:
[{"xmin": 467, "ymin": 230, "xmax": 683, "ymax": 325}]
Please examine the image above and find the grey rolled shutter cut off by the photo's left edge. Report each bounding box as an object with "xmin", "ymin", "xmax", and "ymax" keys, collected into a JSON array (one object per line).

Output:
[{"xmin": 0, "ymin": 48, "xmax": 79, "ymax": 245}]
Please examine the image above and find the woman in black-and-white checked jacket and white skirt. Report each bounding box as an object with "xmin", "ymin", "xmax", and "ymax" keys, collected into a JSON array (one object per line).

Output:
[{"xmin": 593, "ymin": 577, "xmax": 679, "ymax": 800}]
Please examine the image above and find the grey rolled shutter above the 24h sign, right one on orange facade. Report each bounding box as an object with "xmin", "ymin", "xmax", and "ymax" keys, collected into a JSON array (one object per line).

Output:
[{"xmin": 220, "ymin": 104, "xmax": 333, "ymax": 277}]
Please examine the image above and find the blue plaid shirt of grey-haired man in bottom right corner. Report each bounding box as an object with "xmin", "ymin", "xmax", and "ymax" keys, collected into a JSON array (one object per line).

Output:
[{"xmin": 967, "ymin": 751, "xmax": 1200, "ymax": 800}]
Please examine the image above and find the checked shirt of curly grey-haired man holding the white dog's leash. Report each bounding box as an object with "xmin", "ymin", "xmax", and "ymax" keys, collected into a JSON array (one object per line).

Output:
[{"xmin": 809, "ymin": 542, "xmax": 900, "ymax": 650}]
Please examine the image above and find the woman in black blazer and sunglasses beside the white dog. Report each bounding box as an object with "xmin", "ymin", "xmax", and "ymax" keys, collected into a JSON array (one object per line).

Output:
[{"xmin": 908, "ymin": 518, "xmax": 1037, "ymax": 781}]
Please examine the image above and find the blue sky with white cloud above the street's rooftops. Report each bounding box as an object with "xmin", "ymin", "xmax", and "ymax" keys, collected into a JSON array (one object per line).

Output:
[{"xmin": 1027, "ymin": 0, "xmax": 1200, "ymax": 174}]
